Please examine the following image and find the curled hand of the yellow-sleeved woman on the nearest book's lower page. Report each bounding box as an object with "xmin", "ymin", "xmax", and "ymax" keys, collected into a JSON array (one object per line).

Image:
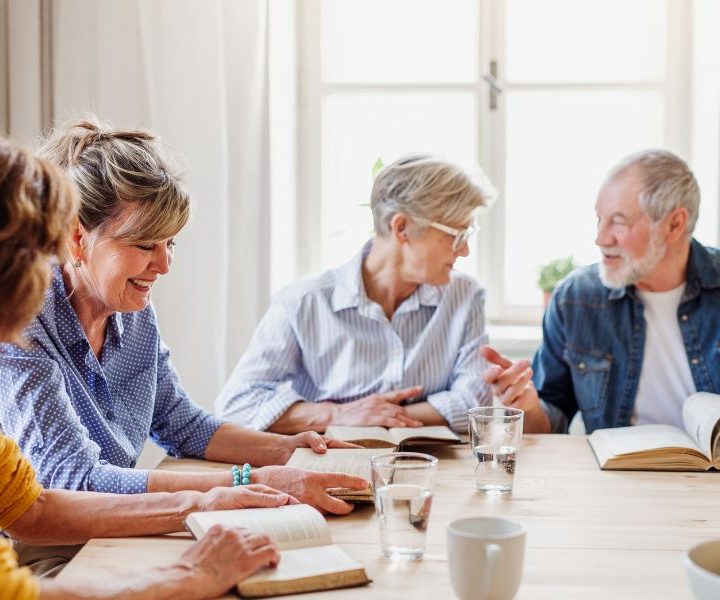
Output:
[{"xmin": 178, "ymin": 525, "xmax": 280, "ymax": 598}]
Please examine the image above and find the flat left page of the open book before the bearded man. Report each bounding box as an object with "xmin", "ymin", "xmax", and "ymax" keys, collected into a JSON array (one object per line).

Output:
[{"xmin": 590, "ymin": 425, "xmax": 700, "ymax": 456}]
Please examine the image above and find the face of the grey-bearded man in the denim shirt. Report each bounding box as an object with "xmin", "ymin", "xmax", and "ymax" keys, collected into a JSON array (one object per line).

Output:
[{"xmin": 595, "ymin": 170, "xmax": 666, "ymax": 288}]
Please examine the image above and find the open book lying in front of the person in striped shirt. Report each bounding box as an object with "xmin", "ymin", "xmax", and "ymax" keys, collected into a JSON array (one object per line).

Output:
[{"xmin": 325, "ymin": 425, "xmax": 462, "ymax": 448}]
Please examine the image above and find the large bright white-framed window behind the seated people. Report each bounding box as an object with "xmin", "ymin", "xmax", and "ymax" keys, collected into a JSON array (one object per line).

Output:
[{"xmin": 286, "ymin": 0, "xmax": 720, "ymax": 323}]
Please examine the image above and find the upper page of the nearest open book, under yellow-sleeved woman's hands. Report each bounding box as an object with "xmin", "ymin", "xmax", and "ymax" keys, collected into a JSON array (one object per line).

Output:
[{"xmin": 187, "ymin": 504, "xmax": 332, "ymax": 550}]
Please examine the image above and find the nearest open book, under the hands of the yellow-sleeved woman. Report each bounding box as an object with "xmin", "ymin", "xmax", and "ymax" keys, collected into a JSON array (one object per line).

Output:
[{"xmin": 185, "ymin": 504, "xmax": 370, "ymax": 598}]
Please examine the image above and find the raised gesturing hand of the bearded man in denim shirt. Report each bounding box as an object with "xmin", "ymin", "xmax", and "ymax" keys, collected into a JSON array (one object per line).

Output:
[{"xmin": 480, "ymin": 346, "xmax": 550, "ymax": 433}]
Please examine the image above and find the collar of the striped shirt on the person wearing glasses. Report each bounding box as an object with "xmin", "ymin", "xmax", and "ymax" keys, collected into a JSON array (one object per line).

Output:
[{"xmin": 331, "ymin": 240, "xmax": 445, "ymax": 313}]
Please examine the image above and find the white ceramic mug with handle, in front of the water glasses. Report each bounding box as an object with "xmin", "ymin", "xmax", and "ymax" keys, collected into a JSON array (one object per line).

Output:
[{"xmin": 447, "ymin": 517, "xmax": 527, "ymax": 600}]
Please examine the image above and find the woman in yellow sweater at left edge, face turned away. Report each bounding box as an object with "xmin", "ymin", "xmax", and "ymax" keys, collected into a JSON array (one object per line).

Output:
[{"xmin": 0, "ymin": 138, "xmax": 286, "ymax": 600}]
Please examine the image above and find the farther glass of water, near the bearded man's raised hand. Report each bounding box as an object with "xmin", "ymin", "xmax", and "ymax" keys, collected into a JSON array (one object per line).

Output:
[{"xmin": 468, "ymin": 406, "xmax": 523, "ymax": 494}]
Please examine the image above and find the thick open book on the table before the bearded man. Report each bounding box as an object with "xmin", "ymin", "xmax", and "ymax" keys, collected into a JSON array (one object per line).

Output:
[{"xmin": 588, "ymin": 392, "xmax": 720, "ymax": 471}]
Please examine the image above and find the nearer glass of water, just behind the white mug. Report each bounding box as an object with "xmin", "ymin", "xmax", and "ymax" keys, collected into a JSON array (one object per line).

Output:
[{"xmin": 372, "ymin": 452, "xmax": 438, "ymax": 560}]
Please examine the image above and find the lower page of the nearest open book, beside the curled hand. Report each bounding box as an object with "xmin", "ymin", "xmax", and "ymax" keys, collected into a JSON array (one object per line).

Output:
[{"xmin": 238, "ymin": 545, "xmax": 363, "ymax": 593}]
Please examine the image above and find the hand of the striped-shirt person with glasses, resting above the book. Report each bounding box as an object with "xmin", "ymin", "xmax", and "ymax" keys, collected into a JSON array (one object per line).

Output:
[{"xmin": 329, "ymin": 386, "xmax": 422, "ymax": 427}]
